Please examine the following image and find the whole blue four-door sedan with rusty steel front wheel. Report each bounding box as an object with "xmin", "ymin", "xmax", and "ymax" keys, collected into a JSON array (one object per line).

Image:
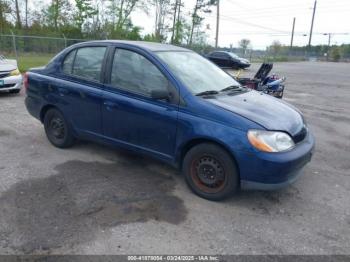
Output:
[{"xmin": 24, "ymin": 40, "xmax": 314, "ymax": 200}]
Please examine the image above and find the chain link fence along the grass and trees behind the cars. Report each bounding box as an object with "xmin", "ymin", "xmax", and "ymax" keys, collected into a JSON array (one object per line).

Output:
[{"xmin": 0, "ymin": 34, "xmax": 350, "ymax": 71}]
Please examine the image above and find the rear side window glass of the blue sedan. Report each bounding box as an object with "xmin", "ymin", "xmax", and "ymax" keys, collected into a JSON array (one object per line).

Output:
[{"xmin": 69, "ymin": 47, "xmax": 106, "ymax": 81}]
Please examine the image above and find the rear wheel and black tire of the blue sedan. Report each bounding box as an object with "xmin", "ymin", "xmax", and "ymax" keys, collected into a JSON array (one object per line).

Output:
[{"xmin": 44, "ymin": 108, "xmax": 75, "ymax": 148}]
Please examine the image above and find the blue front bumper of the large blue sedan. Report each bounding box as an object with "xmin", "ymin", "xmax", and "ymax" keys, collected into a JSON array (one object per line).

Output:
[{"xmin": 239, "ymin": 132, "xmax": 315, "ymax": 190}]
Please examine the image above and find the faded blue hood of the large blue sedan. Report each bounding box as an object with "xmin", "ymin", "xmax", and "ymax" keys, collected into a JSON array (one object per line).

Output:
[{"xmin": 207, "ymin": 91, "xmax": 304, "ymax": 136}]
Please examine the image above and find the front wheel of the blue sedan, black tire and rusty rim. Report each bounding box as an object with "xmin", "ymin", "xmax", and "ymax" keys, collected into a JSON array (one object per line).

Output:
[{"xmin": 182, "ymin": 143, "xmax": 239, "ymax": 201}]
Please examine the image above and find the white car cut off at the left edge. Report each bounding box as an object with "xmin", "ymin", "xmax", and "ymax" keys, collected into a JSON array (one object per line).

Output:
[{"xmin": 0, "ymin": 55, "xmax": 22, "ymax": 93}]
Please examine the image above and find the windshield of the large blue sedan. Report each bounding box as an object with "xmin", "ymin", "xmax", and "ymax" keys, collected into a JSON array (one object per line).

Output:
[{"xmin": 157, "ymin": 51, "xmax": 240, "ymax": 94}]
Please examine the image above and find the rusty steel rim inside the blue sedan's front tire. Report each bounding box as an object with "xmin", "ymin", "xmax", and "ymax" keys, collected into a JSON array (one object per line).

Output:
[{"xmin": 190, "ymin": 155, "xmax": 227, "ymax": 193}]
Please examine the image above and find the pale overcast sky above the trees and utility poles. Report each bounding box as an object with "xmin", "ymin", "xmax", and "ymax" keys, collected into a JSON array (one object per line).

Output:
[{"xmin": 132, "ymin": 0, "xmax": 350, "ymax": 49}]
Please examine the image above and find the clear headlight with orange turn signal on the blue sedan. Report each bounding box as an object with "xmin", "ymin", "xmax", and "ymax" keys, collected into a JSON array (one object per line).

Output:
[{"xmin": 248, "ymin": 130, "xmax": 295, "ymax": 152}]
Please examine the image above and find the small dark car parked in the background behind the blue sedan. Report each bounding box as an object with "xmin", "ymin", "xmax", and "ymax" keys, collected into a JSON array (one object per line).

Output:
[{"xmin": 207, "ymin": 51, "xmax": 250, "ymax": 69}]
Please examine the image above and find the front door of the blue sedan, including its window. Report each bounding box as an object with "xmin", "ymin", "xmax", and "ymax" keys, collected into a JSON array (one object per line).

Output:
[{"xmin": 102, "ymin": 48, "xmax": 179, "ymax": 159}]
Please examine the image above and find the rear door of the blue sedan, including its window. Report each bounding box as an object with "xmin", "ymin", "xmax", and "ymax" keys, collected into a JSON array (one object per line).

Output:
[{"xmin": 54, "ymin": 46, "xmax": 107, "ymax": 134}]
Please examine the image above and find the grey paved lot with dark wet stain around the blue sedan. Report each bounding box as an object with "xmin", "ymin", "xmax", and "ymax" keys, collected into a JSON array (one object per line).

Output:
[{"xmin": 0, "ymin": 63, "xmax": 350, "ymax": 254}]
